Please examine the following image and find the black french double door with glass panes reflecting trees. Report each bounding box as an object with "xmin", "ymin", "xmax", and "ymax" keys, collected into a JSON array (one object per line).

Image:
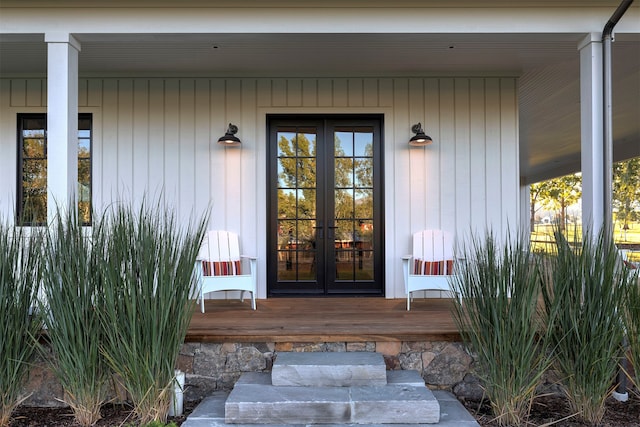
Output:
[{"xmin": 267, "ymin": 115, "xmax": 384, "ymax": 296}]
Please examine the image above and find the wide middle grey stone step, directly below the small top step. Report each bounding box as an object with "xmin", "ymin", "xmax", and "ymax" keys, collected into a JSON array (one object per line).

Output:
[{"xmin": 225, "ymin": 373, "xmax": 440, "ymax": 424}]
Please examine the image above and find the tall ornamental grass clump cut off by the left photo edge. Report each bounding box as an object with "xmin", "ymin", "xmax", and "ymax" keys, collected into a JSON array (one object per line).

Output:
[{"xmin": 0, "ymin": 221, "xmax": 42, "ymax": 427}]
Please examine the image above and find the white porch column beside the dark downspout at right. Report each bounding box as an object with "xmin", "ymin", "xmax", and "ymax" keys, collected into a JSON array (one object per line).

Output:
[{"xmin": 578, "ymin": 33, "xmax": 610, "ymax": 232}]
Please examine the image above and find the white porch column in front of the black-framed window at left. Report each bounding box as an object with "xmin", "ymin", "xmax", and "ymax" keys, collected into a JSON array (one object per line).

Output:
[{"xmin": 44, "ymin": 33, "xmax": 80, "ymax": 222}]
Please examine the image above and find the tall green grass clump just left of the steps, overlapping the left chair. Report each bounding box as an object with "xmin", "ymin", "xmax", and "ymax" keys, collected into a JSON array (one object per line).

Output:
[{"xmin": 94, "ymin": 202, "xmax": 208, "ymax": 424}]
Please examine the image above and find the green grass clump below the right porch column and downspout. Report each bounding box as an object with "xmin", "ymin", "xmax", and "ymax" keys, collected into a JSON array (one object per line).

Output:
[{"xmin": 543, "ymin": 230, "xmax": 628, "ymax": 425}]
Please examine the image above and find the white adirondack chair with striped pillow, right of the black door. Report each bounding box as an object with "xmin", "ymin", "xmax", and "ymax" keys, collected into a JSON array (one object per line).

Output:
[{"xmin": 402, "ymin": 230, "xmax": 455, "ymax": 311}]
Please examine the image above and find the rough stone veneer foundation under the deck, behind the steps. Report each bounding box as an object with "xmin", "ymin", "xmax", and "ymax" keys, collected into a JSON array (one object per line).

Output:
[{"xmin": 24, "ymin": 341, "xmax": 482, "ymax": 406}]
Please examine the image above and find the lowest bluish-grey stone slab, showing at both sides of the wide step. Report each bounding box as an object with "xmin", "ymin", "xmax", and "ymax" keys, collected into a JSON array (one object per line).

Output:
[{"xmin": 182, "ymin": 390, "xmax": 480, "ymax": 427}]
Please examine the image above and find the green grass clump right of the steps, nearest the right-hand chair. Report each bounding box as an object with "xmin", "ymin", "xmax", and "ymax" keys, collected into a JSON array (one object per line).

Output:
[{"xmin": 452, "ymin": 233, "xmax": 549, "ymax": 426}]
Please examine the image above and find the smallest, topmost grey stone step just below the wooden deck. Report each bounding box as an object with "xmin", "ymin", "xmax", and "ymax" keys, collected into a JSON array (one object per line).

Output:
[{"xmin": 271, "ymin": 352, "xmax": 387, "ymax": 387}]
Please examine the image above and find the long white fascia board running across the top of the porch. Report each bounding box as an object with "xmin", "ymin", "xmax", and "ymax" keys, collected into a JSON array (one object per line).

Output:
[{"xmin": 0, "ymin": 7, "xmax": 640, "ymax": 34}]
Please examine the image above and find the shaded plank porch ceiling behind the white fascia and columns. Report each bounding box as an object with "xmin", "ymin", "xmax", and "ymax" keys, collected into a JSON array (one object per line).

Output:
[{"xmin": 0, "ymin": 33, "xmax": 640, "ymax": 183}]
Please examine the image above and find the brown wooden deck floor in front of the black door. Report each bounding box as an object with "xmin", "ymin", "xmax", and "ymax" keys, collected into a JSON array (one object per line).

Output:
[{"xmin": 186, "ymin": 298, "xmax": 460, "ymax": 342}]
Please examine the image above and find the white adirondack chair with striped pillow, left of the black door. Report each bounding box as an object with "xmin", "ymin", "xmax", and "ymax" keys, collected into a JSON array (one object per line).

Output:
[{"xmin": 196, "ymin": 230, "xmax": 257, "ymax": 313}]
